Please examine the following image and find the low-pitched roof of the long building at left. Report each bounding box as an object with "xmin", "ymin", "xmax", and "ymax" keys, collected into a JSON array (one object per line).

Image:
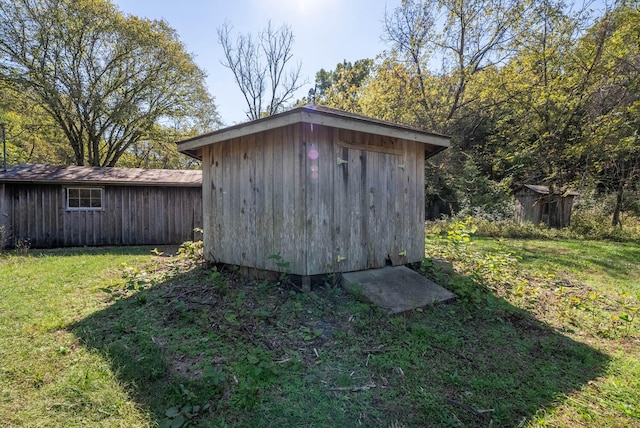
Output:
[{"xmin": 0, "ymin": 165, "xmax": 202, "ymax": 187}]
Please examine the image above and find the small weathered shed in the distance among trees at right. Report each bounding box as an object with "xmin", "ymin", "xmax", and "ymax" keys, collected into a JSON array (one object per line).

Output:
[{"xmin": 514, "ymin": 184, "xmax": 579, "ymax": 227}]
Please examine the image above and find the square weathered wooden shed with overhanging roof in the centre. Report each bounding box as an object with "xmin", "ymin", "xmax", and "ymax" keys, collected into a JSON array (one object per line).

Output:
[{"xmin": 178, "ymin": 105, "xmax": 449, "ymax": 276}]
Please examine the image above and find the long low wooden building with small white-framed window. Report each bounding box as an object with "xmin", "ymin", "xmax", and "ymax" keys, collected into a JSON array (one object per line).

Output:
[{"xmin": 0, "ymin": 165, "xmax": 202, "ymax": 248}]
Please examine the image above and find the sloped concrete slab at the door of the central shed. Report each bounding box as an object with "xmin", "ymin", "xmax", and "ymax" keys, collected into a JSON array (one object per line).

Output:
[{"xmin": 342, "ymin": 266, "xmax": 456, "ymax": 314}]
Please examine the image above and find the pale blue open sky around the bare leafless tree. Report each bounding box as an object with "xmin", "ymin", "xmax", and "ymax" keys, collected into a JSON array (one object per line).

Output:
[{"xmin": 112, "ymin": 0, "xmax": 401, "ymax": 125}]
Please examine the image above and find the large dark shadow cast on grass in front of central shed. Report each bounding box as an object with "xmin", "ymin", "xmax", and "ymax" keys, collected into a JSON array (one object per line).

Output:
[{"xmin": 70, "ymin": 269, "xmax": 608, "ymax": 427}]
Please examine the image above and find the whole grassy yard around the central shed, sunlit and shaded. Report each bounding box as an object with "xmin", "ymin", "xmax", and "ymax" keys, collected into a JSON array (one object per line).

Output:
[{"xmin": 0, "ymin": 235, "xmax": 640, "ymax": 427}]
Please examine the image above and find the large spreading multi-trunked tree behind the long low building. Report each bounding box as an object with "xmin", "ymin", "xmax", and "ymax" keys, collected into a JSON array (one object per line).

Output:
[{"xmin": 0, "ymin": 0, "xmax": 217, "ymax": 166}]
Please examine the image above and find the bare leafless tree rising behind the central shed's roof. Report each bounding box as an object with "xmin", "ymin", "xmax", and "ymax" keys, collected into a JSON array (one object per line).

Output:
[{"xmin": 218, "ymin": 22, "xmax": 304, "ymax": 120}]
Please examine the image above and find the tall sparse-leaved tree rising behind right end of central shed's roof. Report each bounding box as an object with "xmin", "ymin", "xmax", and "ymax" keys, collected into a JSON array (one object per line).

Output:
[{"xmin": 384, "ymin": 0, "xmax": 523, "ymax": 135}]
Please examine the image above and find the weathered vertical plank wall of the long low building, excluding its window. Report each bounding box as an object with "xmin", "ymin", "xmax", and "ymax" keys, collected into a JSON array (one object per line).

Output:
[{"xmin": 0, "ymin": 183, "xmax": 202, "ymax": 248}]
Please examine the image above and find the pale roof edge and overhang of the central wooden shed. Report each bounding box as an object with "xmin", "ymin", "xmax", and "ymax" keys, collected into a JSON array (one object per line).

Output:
[{"xmin": 177, "ymin": 105, "xmax": 450, "ymax": 159}]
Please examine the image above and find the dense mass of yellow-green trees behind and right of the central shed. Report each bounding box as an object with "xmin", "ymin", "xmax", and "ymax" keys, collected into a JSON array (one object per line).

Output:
[{"xmin": 306, "ymin": 0, "xmax": 640, "ymax": 219}]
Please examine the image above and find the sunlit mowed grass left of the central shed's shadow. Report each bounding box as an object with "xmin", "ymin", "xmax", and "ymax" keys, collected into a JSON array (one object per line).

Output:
[{"xmin": 0, "ymin": 249, "xmax": 151, "ymax": 427}]
